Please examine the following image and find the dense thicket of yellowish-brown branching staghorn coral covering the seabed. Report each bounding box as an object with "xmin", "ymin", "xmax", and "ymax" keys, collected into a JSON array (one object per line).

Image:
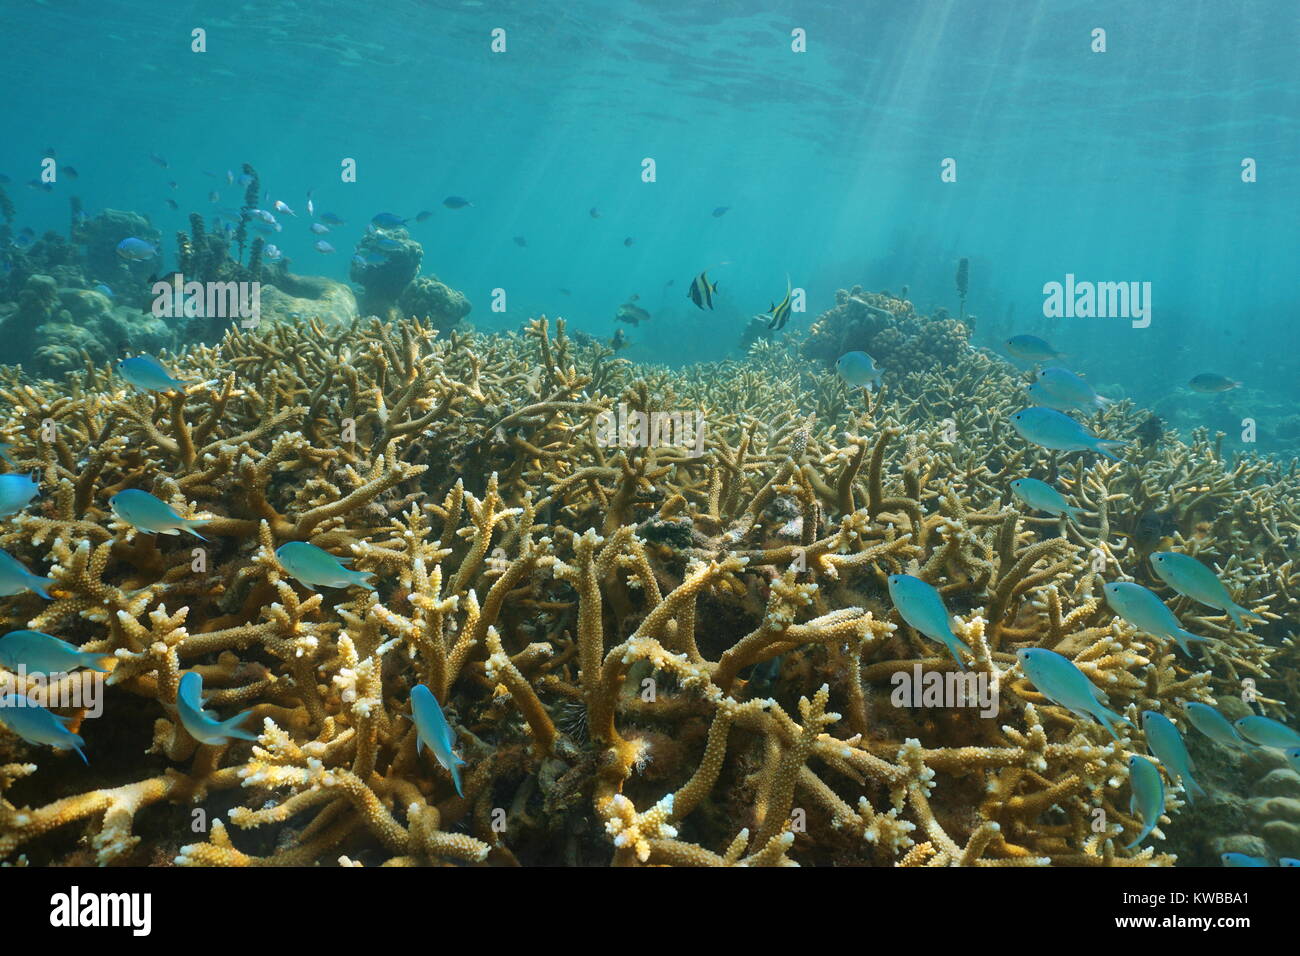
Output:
[{"xmin": 0, "ymin": 297, "xmax": 1300, "ymax": 866}]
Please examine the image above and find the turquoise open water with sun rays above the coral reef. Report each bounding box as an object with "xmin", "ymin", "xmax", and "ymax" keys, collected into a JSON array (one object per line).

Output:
[{"xmin": 0, "ymin": 0, "xmax": 1300, "ymax": 408}]
